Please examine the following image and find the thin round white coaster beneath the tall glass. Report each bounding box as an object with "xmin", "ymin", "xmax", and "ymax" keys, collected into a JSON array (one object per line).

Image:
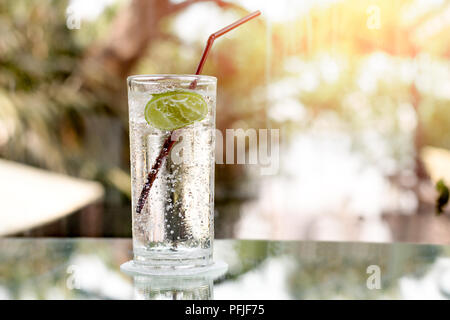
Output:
[{"xmin": 120, "ymin": 260, "xmax": 228, "ymax": 278}]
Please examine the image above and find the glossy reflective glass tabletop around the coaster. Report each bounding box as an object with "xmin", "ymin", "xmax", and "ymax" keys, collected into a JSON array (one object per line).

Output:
[{"xmin": 0, "ymin": 238, "xmax": 450, "ymax": 299}]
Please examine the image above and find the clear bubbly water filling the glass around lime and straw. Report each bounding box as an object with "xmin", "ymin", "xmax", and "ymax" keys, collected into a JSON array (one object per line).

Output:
[{"xmin": 128, "ymin": 78, "xmax": 215, "ymax": 267}]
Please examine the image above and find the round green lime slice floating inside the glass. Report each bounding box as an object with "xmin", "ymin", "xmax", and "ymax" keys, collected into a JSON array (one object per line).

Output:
[{"xmin": 145, "ymin": 91, "xmax": 208, "ymax": 130}]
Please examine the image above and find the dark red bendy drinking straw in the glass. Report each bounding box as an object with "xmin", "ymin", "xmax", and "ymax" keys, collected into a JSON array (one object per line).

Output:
[{"xmin": 136, "ymin": 10, "xmax": 261, "ymax": 213}]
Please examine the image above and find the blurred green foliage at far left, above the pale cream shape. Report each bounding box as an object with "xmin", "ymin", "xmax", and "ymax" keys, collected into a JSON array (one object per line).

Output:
[{"xmin": 0, "ymin": 0, "xmax": 119, "ymax": 178}]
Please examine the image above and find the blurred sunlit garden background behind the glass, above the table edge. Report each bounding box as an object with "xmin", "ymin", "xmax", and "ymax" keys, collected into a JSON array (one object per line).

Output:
[{"xmin": 0, "ymin": 0, "xmax": 450, "ymax": 243}]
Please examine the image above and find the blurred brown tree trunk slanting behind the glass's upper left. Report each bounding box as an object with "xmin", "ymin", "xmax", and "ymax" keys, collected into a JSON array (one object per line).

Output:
[{"xmin": 72, "ymin": 0, "xmax": 174, "ymax": 114}]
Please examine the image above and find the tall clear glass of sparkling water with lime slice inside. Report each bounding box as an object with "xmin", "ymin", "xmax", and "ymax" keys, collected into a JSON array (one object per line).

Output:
[{"xmin": 127, "ymin": 75, "xmax": 217, "ymax": 269}]
